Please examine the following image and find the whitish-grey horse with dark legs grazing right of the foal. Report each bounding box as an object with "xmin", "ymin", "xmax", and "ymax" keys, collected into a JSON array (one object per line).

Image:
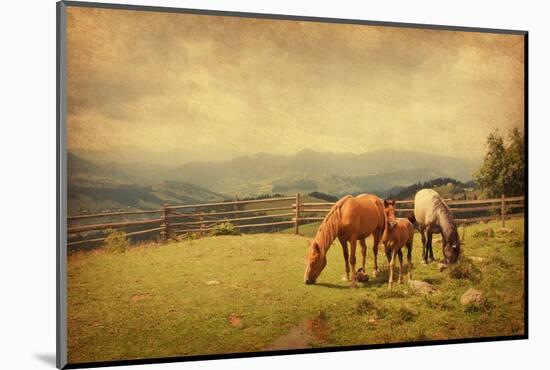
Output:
[{"xmin": 414, "ymin": 189, "xmax": 460, "ymax": 264}]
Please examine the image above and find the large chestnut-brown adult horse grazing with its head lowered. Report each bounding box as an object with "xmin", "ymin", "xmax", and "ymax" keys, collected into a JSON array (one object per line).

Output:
[{"xmin": 304, "ymin": 194, "xmax": 384, "ymax": 287}]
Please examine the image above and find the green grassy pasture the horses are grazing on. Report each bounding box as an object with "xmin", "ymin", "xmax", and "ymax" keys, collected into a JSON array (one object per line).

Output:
[{"xmin": 68, "ymin": 220, "xmax": 524, "ymax": 363}]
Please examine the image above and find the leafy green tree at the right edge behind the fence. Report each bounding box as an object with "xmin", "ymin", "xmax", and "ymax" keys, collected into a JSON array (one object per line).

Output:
[{"xmin": 474, "ymin": 128, "xmax": 525, "ymax": 197}]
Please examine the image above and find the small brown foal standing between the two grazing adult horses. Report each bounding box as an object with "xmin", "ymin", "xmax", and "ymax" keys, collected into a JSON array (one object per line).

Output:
[{"xmin": 382, "ymin": 200, "xmax": 414, "ymax": 288}]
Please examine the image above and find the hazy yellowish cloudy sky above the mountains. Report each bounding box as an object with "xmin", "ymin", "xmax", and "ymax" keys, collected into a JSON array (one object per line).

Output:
[{"xmin": 68, "ymin": 7, "xmax": 524, "ymax": 162}]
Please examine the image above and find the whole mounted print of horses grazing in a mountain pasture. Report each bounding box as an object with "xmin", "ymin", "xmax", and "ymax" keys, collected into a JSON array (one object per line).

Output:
[{"xmin": 57, "ymin": 1, "xmax": 528, "ymax": 368}]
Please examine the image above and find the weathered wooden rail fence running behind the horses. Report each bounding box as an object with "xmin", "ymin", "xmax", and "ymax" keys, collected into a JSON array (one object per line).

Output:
[{"xmin": 67, "ymin": 194, "xmax": 525, "ymax": 247}]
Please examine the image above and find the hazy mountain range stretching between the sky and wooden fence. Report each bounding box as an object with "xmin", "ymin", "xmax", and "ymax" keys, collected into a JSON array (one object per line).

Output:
[{"xmin": 68, "ymin": 149, "xmax": 479, "ymax": 213}]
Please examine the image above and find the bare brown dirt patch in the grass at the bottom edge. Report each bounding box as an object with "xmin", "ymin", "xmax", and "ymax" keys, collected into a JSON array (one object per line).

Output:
[{"xmin": 265, "ymin": 315, "xmax": 330, "ymax": 351}]
